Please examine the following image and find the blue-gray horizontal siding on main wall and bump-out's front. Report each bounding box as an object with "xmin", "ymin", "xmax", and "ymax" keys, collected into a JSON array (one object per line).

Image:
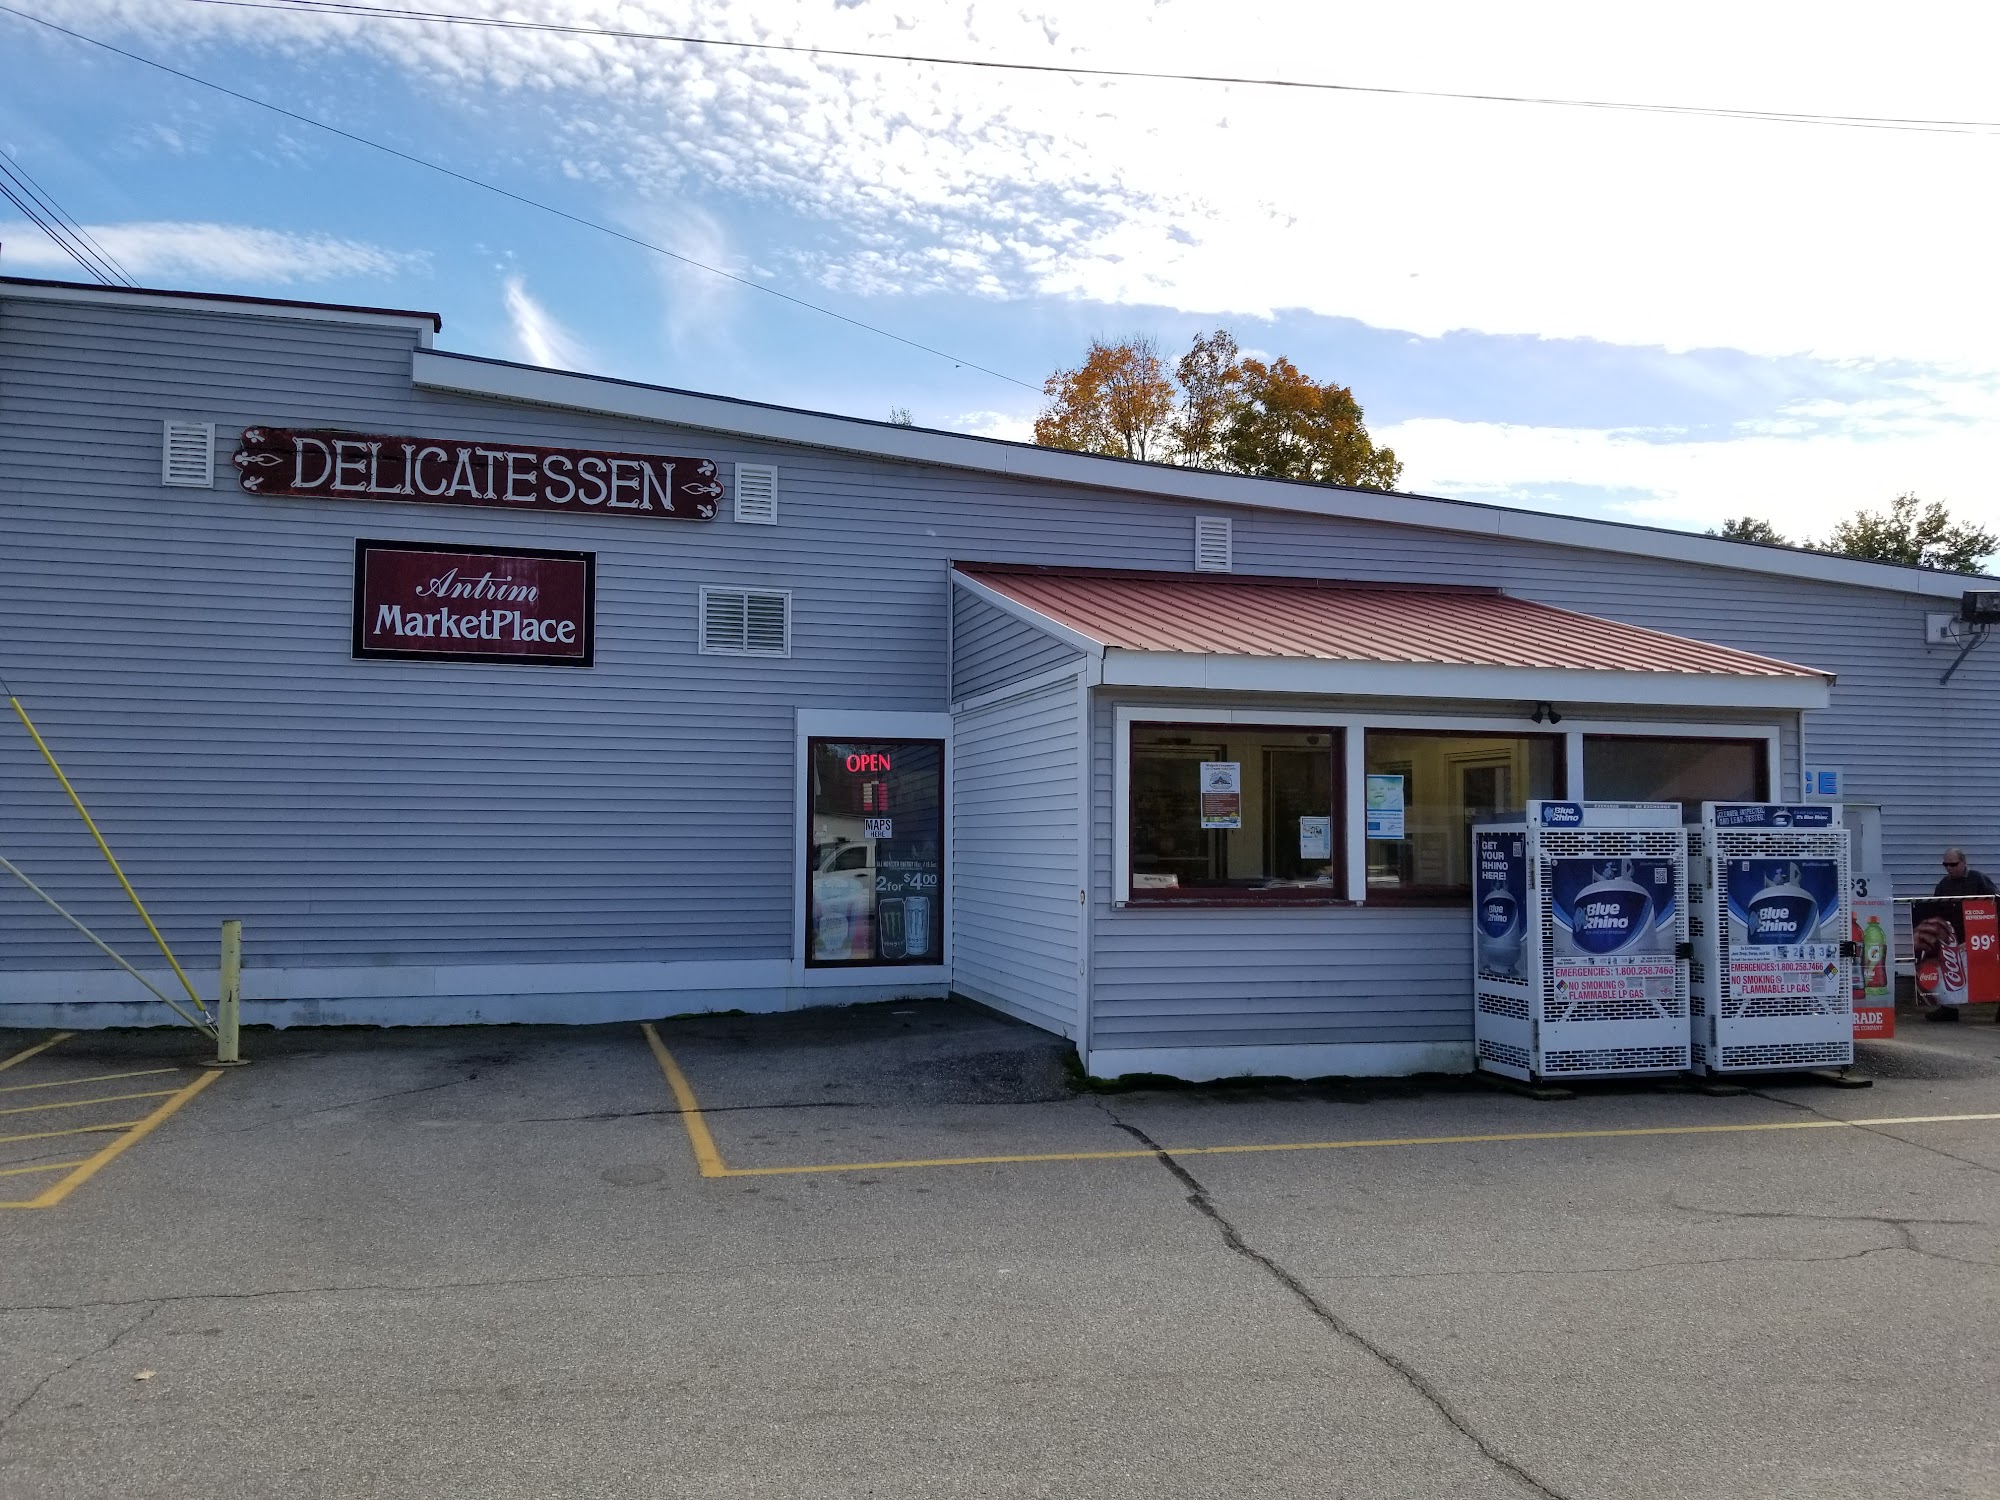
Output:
[{"xmin": 0, "ymin": 288, "xmax": 2000, "ymax": 1046}]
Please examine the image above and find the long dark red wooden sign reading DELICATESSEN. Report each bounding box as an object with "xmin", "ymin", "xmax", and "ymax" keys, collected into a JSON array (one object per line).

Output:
[{"xmin": 234, "ymin": 428, "xmax": 722, "ymax": 520}]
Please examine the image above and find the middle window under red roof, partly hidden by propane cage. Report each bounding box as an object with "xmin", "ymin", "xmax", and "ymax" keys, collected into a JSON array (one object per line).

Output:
[{"xmin": 1364, "ymin": 730, "xmax": 1562, "ymax": 898}]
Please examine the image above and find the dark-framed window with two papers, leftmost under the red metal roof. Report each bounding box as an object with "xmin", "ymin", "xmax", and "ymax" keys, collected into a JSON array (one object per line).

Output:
[{"xmin": 1128, "ymin": 724, "xmax": 1342, "ymax": 902}]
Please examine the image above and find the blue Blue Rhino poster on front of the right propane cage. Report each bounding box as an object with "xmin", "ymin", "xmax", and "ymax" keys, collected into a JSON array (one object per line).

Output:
[{"xmin": 1724, "ymin": 860, "xmax": 1846, "ymax": 1000}]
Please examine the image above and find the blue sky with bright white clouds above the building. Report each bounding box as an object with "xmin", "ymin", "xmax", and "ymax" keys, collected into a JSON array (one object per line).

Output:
[{"xmin": 0, "ymin": 0, "xmax": 2000, "ymax": 534}]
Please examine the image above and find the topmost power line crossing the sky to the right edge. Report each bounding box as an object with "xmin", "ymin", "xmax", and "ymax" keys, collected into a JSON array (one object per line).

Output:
[{"xmin": 172, "ymin": 0, "xmax": 2000, "ymax": 136}]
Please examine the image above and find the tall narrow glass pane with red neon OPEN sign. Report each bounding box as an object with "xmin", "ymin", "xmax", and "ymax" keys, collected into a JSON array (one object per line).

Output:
[{"xmin": 806, "ymin": 740, "xmax": 944, "ymax": 964}]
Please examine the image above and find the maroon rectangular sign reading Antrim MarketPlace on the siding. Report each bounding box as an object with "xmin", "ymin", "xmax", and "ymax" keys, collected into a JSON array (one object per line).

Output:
[{"xmin": 354, "ymin": 542, "xmax": 598, "ymax": 666}]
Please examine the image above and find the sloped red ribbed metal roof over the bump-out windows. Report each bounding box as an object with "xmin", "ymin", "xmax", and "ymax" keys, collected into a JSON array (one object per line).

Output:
[{"xmin": 954, "ymin": 562, "xmax": 1832, "ymax": 680}]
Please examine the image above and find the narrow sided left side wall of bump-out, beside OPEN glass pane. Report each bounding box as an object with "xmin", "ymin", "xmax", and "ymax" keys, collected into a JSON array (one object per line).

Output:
[{"xmin": 950, "ymin": 674, "xmax": 1086, "ymax": 1036}]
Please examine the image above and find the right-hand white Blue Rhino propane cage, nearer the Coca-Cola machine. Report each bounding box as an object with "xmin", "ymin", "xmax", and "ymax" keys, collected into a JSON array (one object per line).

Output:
[{"xmin": 1690, "ymin": 802, "xmax": 1854, "ymax": 1072}]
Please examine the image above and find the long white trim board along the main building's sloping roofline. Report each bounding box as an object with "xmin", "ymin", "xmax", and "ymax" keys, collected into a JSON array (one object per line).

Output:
[{"xmin": 412, "ymin": 352, "xmax": 1994, "ymax": 600}]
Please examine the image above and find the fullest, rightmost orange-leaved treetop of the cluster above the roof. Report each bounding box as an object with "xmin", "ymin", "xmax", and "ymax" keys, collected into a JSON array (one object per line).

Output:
[{"xmin": 1220, "ymin": 356, "xmax": 1402, "ymax": 490}]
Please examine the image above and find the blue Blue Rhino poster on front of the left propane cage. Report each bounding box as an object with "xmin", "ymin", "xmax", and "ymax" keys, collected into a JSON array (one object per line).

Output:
[{"xmin": 1548, "ymin": 858, "xmax": 1678, "ymax": 1006}]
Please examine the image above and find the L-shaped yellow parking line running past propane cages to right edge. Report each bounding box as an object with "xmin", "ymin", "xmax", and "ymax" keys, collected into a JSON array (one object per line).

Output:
[{"xmin": 640, "ymin": 1022, "xmax": 2000, "ymax": 1178}]
